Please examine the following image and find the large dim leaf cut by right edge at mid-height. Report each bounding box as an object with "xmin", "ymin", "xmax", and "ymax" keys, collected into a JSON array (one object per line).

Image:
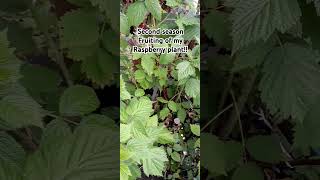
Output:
[{"xmin": 259, "ymin": 43, "xmax": 320, "ymax": 122}]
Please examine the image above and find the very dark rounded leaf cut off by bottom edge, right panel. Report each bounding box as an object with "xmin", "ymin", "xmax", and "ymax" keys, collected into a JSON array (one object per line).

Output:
[{"xmin": 232, "ymin": 163, "xmax": 264, "ymax": 180}]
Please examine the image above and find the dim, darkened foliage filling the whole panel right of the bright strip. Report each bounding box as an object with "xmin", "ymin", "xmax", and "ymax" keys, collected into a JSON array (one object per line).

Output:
[{"xmin": 201, "ymin": 0, "xmax": 320, "ymax": 180}]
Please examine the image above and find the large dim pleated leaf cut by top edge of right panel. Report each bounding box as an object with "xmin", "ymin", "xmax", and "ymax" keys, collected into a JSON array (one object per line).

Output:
[{"xmin": 231, "ymin": 0, "xmax": 301, "ymax": 53}]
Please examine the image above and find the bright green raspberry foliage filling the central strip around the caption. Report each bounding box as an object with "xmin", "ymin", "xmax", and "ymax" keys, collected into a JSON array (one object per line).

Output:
[{"xmin": 120, "ymin": 0, "xmax": 200, "ymax": 180}]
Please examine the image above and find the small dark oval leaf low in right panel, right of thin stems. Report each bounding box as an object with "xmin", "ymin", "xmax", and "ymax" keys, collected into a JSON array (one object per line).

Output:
[{"xmin": 246, "ymin": 135, "xmax": 285, "ymax": 163}]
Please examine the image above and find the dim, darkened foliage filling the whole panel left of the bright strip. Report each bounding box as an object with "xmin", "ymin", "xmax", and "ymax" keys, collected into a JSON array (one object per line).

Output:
[{"xmin": 0, "ymin": 0, "xmax": 119, "ymax": 180}]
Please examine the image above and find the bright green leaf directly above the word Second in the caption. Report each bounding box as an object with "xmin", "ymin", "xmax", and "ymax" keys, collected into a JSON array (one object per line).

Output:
[{"xmin": 127, "ymin": 1, "xmax": 148, "ymax": 26}]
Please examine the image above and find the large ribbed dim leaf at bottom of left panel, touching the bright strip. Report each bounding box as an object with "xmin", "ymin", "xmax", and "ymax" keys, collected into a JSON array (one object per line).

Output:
[{"xmin": 24, "ymin": 125, "xmax": 119, "ymax": 180}]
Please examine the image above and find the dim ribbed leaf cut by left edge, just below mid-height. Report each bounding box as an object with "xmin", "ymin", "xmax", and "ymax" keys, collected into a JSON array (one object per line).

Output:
[{"xmin": 0, "ymin": 93, "xmax": 45, "ymax": 128}]
